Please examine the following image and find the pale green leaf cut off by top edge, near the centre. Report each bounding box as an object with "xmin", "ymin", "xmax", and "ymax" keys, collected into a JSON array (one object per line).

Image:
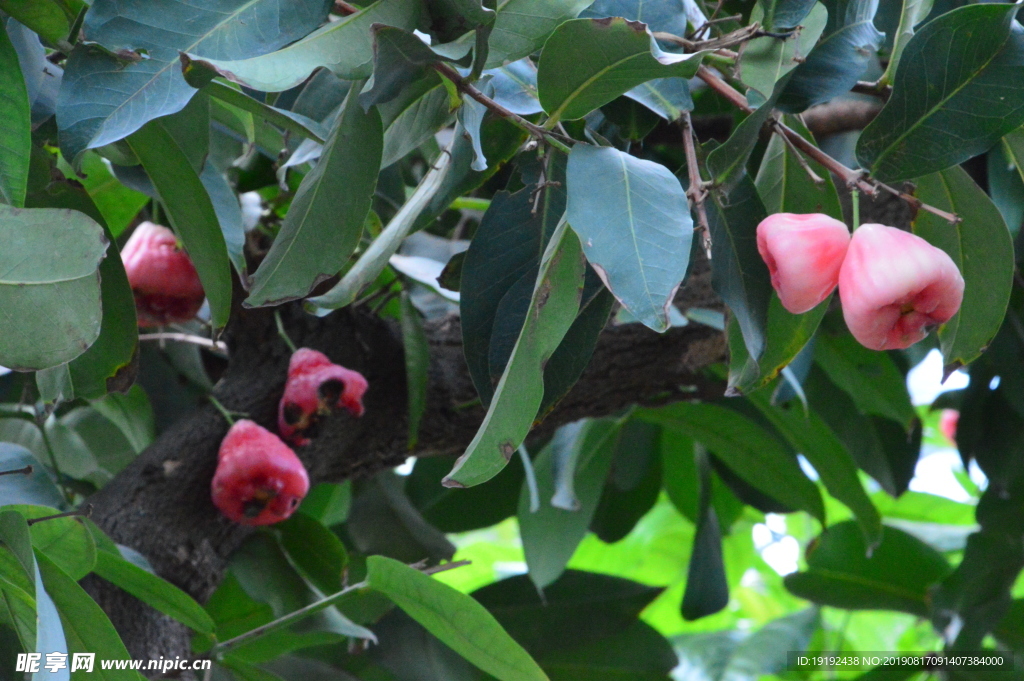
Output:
[{"xmin": 486, "ymin": 0, "xmax": 591, "ymax": 69}]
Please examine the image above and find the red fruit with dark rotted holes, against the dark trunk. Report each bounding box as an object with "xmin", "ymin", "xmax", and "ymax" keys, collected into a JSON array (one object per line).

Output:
[{"xmin": 278, "ymin": 347, "xmax": 369, "ymax": 445}]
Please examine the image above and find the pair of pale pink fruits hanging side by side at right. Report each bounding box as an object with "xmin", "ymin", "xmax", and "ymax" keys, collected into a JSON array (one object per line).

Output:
[{"xmin": 758, "ymin": 213, "xmax": 964, "ymax": 350}]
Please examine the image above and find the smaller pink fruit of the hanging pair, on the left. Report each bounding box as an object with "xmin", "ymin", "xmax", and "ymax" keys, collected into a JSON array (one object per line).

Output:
[{"xmin": 758, "ymin": 213, "xmax": 850, "ymax": 314}]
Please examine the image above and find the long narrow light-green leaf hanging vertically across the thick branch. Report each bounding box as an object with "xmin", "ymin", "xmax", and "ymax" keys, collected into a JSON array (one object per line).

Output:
[{"xmin": 443, "ymin": 222, "xmax": 585, "ymax": 486}]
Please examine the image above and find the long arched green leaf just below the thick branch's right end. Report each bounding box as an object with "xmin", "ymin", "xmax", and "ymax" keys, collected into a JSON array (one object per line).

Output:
[{"xmin": 641, "ymin": 403, "xmax": 824, "ymax": 522}]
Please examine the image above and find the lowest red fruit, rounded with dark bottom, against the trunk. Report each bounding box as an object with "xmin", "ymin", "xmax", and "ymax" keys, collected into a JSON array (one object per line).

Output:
[{"xmin": 210, "ymin": 419, "xmax": 309, "ymax": 525}]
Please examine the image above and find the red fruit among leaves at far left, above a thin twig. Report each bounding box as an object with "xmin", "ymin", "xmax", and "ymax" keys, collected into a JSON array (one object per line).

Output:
[{"xmin": 121, "ymin": 222, "xmax": 206, "ymax": 327}]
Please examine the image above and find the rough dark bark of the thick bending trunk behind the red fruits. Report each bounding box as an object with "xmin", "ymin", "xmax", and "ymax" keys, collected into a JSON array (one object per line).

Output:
[{"xmin": 89, "ymin": 262, "xmax": 725, "ymax": 671}]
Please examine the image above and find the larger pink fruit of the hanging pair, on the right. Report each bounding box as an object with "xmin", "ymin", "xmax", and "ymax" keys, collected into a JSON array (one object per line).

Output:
[{"xmin": 839, "ymin": 224, "xmax": 964, "ymax": 350}]
